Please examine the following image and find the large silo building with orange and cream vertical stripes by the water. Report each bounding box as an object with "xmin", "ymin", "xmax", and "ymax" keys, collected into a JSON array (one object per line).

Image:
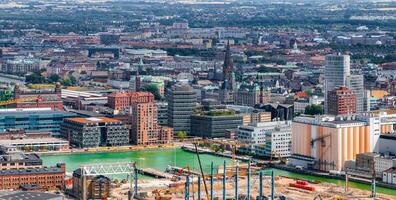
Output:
[{"xmin": 289, "ymin": 116, "xmax": 380, "ymax": 171}]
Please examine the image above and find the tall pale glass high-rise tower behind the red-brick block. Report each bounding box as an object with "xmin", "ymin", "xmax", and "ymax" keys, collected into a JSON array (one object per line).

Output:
[{"xmin": 324, "ymin": 55, "xmax": 367, "ymax": 114}]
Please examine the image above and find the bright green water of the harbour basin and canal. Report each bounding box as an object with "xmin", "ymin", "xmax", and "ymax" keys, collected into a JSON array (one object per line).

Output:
[{"xmin": 41, "ymin": 149, "xmax": 396, "ymax": 195}]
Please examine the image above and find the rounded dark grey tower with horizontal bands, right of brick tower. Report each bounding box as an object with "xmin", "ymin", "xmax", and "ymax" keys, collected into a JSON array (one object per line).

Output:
[{"xmin": 167, "ymin": 83, "xmax": 197, "ymax": 134}]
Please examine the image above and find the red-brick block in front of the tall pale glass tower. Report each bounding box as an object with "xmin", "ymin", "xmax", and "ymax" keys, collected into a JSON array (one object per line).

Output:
[{"xmin": 327, "ymin": 87, "xmax": 356, "ymax": 115}]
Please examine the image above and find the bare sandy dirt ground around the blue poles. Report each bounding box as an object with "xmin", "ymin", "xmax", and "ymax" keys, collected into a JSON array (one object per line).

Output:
[{"xmin": 112, "ymin": 176, "xmax": 396, "ymax": 200}]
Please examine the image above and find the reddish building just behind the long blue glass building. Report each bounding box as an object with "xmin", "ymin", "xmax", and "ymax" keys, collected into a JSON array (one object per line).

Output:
[{"xmin": 12, "ymin": 84, "xmax": 63, "ymax": 110}]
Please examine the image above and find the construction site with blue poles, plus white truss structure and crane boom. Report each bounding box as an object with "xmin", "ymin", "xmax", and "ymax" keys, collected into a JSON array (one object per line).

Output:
[{"xmin": 73, "ymin": 142, "xmax": 396, "ymax": 200}]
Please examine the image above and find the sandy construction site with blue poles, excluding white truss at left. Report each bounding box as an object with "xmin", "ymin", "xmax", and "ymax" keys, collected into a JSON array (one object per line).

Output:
[{"xmin": 106, "ymin": 162, "xmax": 395, "ymax": 200}]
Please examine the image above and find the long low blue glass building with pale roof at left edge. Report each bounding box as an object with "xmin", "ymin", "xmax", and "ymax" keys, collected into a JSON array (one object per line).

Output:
[{"xmin": 0, "ymin": 108, "xmax": 76, "ymax": 135}]
